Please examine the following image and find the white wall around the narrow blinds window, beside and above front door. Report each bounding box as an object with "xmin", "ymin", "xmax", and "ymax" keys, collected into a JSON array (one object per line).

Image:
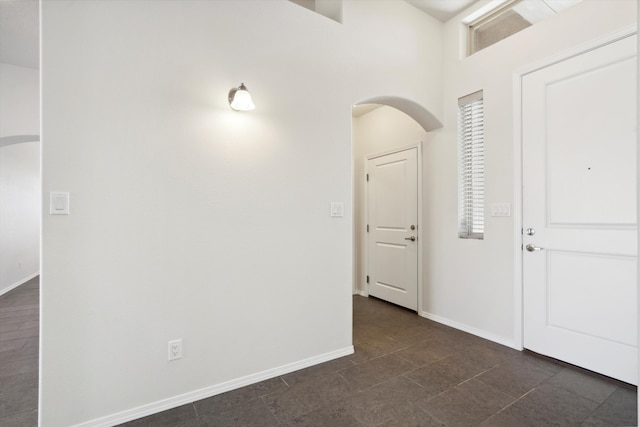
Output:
[{"xmin": 423, "ymin": 0, "xmax": 636, "ymax": 347}]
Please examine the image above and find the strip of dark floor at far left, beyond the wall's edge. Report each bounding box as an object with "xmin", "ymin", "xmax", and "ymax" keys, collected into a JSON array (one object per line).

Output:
[{"xmin": 0, "ymin": 278, "xmax": 39, "ymax": 427}]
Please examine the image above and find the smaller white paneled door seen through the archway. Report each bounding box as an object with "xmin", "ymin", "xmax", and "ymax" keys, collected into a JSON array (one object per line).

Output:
[{"xmin": 367, "ymin": 148, "xmax": 418, "ymax": 310}]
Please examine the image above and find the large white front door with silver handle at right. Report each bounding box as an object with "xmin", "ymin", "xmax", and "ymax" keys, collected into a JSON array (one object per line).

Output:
[{"xmin": 522, "ymin": 35, "xmax": 638, "ymax": 384}]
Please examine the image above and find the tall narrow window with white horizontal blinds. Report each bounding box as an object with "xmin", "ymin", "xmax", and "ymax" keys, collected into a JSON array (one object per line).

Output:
[{"xmin": 458, "ymin": 91, "xmax": 484, "ymax": 239}]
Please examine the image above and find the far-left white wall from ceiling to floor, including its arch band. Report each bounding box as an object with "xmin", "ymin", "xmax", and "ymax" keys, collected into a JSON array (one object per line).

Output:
[{"xmin": 0, "ymin": 63, "xmax": 40, "ymax": 295}]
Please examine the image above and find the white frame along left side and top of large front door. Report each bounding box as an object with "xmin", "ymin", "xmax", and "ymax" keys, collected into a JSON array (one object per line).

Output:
[{"xmin": 513, "ymin": 25, "xmax": 640, "ymax": 350}]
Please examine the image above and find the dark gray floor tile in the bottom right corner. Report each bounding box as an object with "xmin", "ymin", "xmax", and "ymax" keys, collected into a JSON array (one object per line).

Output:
[{"xmin": 583, "ymin": 387, "xmax": 638, "ymax": 426}]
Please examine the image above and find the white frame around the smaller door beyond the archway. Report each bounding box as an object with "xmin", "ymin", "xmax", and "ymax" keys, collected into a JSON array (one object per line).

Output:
[{"xmin": 358, "ymin": 141, "xmax": 424, "ymax": 315}]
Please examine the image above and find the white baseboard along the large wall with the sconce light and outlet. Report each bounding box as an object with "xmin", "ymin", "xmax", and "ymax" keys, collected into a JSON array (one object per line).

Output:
[{"xmin": 75, "ymin": 346, "xmax": 354, "ymax": 427}]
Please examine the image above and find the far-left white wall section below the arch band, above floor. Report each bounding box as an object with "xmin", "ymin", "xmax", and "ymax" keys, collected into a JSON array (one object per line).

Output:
[{"xmin": 0, "ymin": 141, "xmax": 40, "ymax": 295}]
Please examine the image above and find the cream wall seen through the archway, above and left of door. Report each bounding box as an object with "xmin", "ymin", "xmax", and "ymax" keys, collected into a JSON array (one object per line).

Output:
[{"xmin": 352, "ymin": 106, "xmax": 428, "ymax": 294}]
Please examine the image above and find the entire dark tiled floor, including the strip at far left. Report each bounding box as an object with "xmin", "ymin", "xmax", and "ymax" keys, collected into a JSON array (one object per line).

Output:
[{"xmin": 0, "ymin": 279, "xmax": 637, "ymax": 427}]
